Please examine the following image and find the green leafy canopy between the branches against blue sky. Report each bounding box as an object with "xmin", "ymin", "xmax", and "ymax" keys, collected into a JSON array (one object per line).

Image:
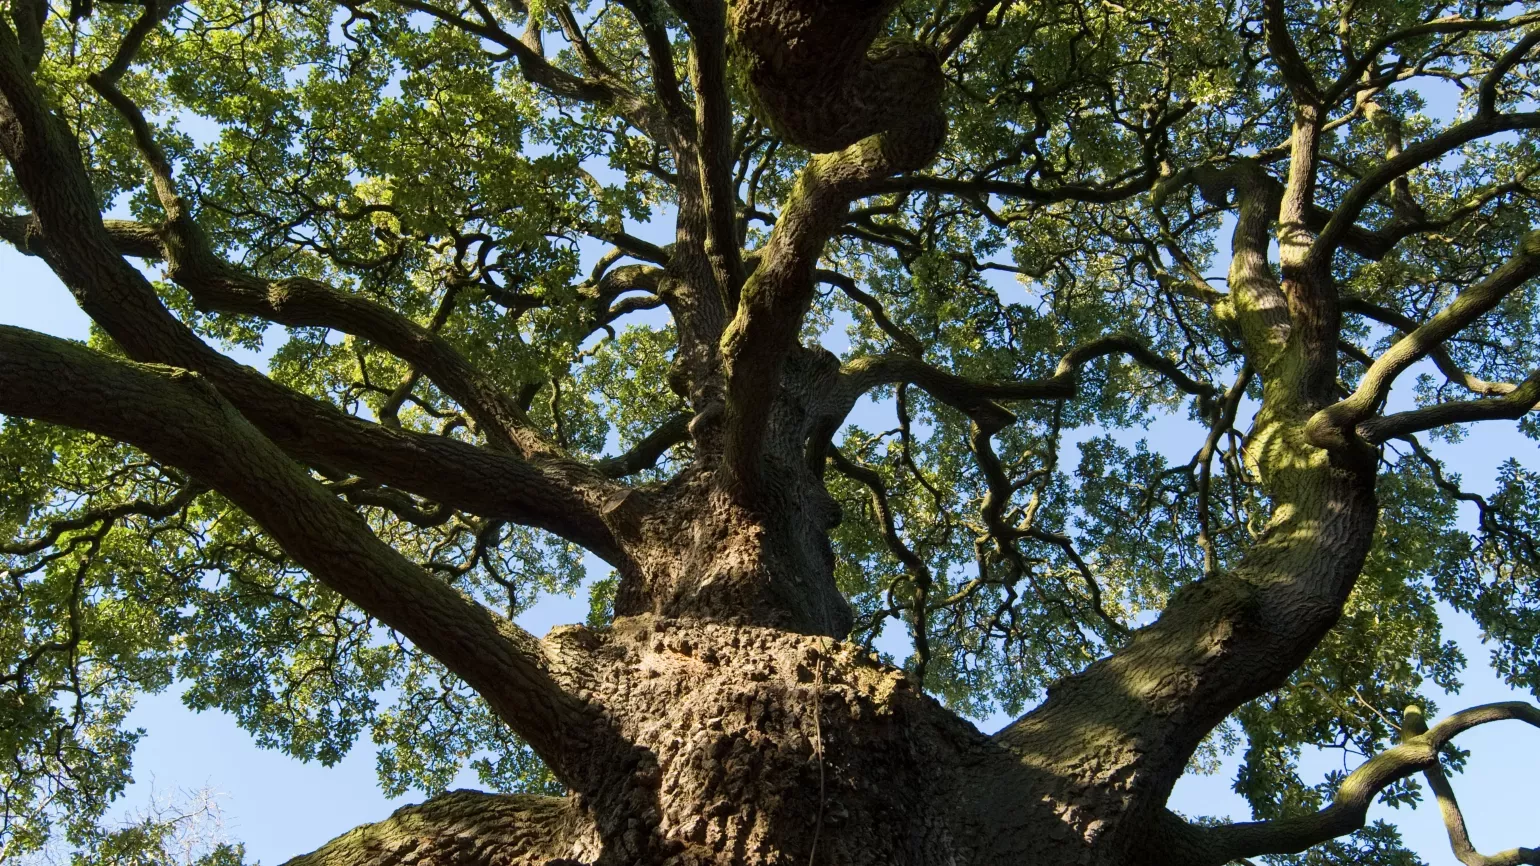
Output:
[{"xmin": 0, "ymin": 0, "xmax": 1540, "ymax": 864}]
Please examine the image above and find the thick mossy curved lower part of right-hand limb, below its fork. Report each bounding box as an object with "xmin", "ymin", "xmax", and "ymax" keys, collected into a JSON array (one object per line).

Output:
[{"xmin": 993, "ymin": 355, "xmax": 1378, "ymax": 861}]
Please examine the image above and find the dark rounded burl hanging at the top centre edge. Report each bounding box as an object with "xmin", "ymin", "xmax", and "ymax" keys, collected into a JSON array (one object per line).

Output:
[{"xmin": 730, "ymin": 0, "xmax": 946, "ymax": 174}]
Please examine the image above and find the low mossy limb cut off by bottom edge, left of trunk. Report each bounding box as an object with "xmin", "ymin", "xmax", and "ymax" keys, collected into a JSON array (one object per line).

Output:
[{"xmin": 283, "ymin": 790, "xmax": 599, "ymax": 866}]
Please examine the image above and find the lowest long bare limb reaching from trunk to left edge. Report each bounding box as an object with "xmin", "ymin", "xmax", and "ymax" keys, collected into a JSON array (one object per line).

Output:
[{"xmin": 0, "ymin": 327, "xmax": 585, "ymax": 767}]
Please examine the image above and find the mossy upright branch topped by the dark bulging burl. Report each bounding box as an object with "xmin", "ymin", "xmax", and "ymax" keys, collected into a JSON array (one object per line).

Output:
[{"xmin": 721, "ymin": 0, "xmax": 946, "ymax": 493}]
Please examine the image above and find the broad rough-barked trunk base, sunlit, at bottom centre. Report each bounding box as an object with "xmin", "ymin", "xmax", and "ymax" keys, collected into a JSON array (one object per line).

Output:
[{"xmin": 550, "ymin": 616, "xmax": 1007, "ymax": 864}]
